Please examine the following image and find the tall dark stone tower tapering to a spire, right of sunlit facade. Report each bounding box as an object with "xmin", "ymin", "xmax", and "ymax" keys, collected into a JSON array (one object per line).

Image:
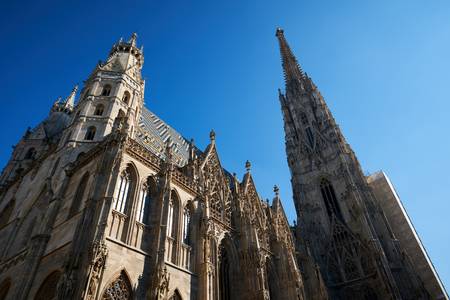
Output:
[{"xmin": 276, "ymin": 29, "xmax": 428, "ymax": 299}]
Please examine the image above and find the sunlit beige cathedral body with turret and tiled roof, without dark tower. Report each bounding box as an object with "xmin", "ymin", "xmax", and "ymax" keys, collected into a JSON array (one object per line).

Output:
[{"xmin": 0, "ymin": 35, "xmax": 304, "ymax": 300}]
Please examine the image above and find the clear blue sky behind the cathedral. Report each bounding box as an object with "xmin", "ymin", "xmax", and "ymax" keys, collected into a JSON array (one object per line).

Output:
[{"xmin": 0, "ymin": 0, "xmax": 450, "ymax": 287}]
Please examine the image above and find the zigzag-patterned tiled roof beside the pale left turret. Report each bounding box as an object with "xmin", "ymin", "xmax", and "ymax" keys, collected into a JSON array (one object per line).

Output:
[{"xmin": 136, "ymin": 107, "xmax": 189, "ymax": 167}]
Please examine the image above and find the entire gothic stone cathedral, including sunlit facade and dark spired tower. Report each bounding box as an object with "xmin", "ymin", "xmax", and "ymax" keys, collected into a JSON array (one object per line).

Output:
[{"xmin": 0, "ymin": 29, "xmax": 448, "ymax": 300}]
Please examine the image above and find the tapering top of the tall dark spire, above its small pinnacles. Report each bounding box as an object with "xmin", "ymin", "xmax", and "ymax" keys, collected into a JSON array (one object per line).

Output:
[{"xmin": 275, "ymin": 28, "xmax": 305, "ymax": 90}]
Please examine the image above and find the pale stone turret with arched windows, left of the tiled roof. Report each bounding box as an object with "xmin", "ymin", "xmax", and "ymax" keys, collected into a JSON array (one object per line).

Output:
[{"xmin": 67, "ymin": 33, "xmax": 144, "ymax": 144}]
